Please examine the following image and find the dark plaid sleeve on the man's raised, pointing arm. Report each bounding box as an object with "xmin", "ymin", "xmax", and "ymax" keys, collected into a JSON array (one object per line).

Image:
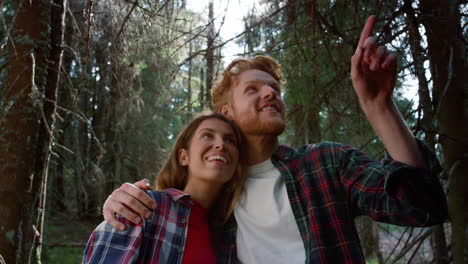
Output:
[{"xmin": 333, "ymin": 139, "xmax": 448, "ymax": 226}]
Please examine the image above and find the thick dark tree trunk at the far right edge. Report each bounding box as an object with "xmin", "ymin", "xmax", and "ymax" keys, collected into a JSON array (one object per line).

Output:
[{"xmin": 420, "ymin": 0, "xmax": 468, "ymax": 264}]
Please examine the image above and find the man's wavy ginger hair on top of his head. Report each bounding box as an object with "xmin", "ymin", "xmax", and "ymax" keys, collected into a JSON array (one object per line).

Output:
[{"xmin": 211, "ymin": 55, "xmax": 286, "ymax": 113}]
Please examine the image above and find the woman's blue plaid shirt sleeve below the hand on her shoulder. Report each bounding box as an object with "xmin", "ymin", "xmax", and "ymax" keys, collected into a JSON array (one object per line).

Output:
[{"xmin": 83, "ymin": 216, "xmax": 144, "ymax": 263}]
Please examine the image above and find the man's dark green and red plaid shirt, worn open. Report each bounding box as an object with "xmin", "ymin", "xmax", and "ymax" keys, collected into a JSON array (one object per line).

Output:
[{"xmin": 220, "ymin": 139, "xmax": 447, "ymax": 264}]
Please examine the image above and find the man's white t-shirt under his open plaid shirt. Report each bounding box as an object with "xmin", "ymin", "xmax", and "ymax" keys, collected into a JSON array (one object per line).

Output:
[{"xmin": 234, "ymin": 160, "xmax": 305, "ymax": 264}]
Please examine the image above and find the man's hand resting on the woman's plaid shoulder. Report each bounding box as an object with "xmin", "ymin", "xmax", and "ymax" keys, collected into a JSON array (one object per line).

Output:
[{"xmin": 102, "ymin": 179, "xmax": 157, "ymax": 230}]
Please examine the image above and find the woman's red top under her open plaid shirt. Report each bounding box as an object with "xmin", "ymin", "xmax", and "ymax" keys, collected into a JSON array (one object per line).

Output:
[{"xmin": 182, "ymin": 200, "xmax": 216, "ymax": 264}]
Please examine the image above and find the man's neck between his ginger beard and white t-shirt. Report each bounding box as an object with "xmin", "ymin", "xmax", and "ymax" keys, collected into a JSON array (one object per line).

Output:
[{"xmin": 245, "ymin": 135, "xmax": 278, "ymax": 165}]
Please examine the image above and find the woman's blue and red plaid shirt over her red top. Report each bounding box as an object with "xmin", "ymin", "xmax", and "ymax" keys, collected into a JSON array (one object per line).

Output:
[{"xmin": 83, "ymin": 189, "xmax": 192, "ymax": 264}]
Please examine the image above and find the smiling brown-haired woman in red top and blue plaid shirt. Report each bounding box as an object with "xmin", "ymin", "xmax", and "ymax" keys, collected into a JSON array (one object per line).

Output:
[{"xmin": 83, "ymin": 114, "xmax": 244, "ymax": 264}]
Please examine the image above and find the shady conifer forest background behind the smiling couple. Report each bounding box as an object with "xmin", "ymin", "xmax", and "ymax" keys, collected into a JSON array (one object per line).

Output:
[{"xmin": 0, "ymin": 0, "xmax": 468, "ymax": 264}]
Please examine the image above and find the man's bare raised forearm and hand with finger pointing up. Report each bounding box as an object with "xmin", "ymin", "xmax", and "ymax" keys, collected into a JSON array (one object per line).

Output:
[{"xmin": 351, "ymin": 16, "xmax": 426, "ymax": 168}]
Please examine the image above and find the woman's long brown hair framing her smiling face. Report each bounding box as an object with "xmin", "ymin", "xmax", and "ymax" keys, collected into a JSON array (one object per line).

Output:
[{"xmin": 155, "ymin": 111, "xmax": 246, "ymax": 227}]
